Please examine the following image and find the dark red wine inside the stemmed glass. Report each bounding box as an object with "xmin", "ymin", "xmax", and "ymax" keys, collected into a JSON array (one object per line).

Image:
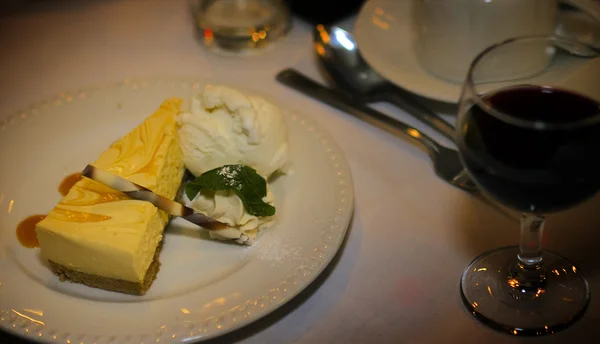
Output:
[{"xmin": 459, "ymin": 86, "xmax": 600, "ymax": 214}]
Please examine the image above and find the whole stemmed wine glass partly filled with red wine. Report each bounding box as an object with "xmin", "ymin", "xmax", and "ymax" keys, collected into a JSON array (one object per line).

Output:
[{"xmin": 457, "ymin": 37, "xmax": 600, "ymax": 335}]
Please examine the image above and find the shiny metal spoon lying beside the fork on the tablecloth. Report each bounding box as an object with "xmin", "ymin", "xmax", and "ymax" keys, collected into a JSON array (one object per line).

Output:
[{"xmin": 313, "ymin": 25, "xmax": 455, "ymax": 142}]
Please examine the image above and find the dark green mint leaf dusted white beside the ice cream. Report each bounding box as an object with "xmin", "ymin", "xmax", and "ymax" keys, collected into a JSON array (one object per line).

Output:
[{"xmin": 185, "ymin": 165, "xmax": 275, "ymax": 216}]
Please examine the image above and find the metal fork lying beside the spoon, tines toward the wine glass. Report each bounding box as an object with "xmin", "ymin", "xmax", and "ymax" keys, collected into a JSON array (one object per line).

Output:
[{"xmin": 275, "ymin": 68, "xmax": 518, "ymax": 221}]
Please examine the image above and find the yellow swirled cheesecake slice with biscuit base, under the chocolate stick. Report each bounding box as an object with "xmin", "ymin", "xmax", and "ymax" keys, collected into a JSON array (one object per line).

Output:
[{"xmin": 36, "ymin": 98, "xmax": 184, "ymax": 295}]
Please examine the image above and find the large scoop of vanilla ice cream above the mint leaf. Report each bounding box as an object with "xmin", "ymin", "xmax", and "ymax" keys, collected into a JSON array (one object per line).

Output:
[{"xmin": 178, "ymin": 85, "xmax": 288, "ymax": 178}]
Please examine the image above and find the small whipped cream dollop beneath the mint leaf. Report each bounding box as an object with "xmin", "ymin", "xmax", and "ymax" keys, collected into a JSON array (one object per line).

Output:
[{"xmin": 183, "ymin": 185, "xmax": 275, "ymax": 245}]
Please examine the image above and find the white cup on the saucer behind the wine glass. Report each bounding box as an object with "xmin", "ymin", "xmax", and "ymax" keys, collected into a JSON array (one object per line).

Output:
[{"xmin": 414, "ymin": 0, "xmax": 600, "ymax": 83}]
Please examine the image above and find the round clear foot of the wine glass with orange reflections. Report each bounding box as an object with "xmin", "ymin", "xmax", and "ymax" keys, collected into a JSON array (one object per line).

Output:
[{"xmin": 461, "ymin": 247, "xmax": 590, "ymax": 336}]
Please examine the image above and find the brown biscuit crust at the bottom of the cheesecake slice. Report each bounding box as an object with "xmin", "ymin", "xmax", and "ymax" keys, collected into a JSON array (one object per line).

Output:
[{"xmin": 49, "ymin": 239, "xmax": 164, "ymax": 296}]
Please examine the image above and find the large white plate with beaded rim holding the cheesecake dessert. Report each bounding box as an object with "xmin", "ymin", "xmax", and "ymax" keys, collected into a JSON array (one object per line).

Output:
[{"xmin": 0, "ymin": 79, "xmax": 353, "ymax": 344}]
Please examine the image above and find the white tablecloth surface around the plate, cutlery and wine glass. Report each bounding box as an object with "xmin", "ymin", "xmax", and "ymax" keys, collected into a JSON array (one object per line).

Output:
[{"xmin": 0, "ymin": 0, "xmax": 600, "ymax": 343}]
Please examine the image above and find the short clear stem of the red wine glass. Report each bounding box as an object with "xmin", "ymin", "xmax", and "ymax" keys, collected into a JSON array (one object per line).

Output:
[{"xmin": 518, "ymin": 214, "xmax": 545, "ymax": 268}]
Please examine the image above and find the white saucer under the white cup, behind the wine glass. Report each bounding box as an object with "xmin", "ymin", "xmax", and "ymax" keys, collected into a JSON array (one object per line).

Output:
[{"xmin": 354, "ymin": 0, "xmax": 462, "ymax": 103}]
